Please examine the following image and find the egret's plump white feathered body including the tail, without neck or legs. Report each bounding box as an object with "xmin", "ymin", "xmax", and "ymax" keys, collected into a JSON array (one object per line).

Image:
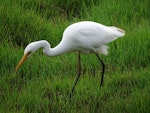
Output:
[{"xmin": 59, "ymin": 21, "xmax": 125, "ymax": 54}]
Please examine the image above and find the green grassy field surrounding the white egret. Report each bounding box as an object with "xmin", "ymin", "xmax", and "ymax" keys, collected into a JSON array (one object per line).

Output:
[{"xmin": 0, "ymin": 0, "xmax": 150, "ymax": 113}]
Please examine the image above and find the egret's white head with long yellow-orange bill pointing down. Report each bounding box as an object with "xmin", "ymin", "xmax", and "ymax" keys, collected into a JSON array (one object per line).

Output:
[{"xmin": 15, "ymin": 42, "xmax": 38, "ymax": 71}]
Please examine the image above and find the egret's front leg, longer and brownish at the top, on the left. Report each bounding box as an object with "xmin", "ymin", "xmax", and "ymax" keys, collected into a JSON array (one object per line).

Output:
[{"xmin": 70, "ymin": 52, "xmax": 81, "ymax": 98}]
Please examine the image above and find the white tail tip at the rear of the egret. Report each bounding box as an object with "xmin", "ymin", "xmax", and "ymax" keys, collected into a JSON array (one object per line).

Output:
[{"xmin": 110, "ymin": 26, "xmax": 125, "ymax": 37}]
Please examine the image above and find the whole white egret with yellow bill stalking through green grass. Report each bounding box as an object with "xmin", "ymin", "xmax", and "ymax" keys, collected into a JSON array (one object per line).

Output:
[{"xmin": 15, "ymin": 21, "xmax": 125, "ymax": 97}]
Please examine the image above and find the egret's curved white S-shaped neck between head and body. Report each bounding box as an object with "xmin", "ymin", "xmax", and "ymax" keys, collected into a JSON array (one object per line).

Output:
[{"xmin": 40, "ymin": 40, "xmax": 68, "ymax": 56}]
